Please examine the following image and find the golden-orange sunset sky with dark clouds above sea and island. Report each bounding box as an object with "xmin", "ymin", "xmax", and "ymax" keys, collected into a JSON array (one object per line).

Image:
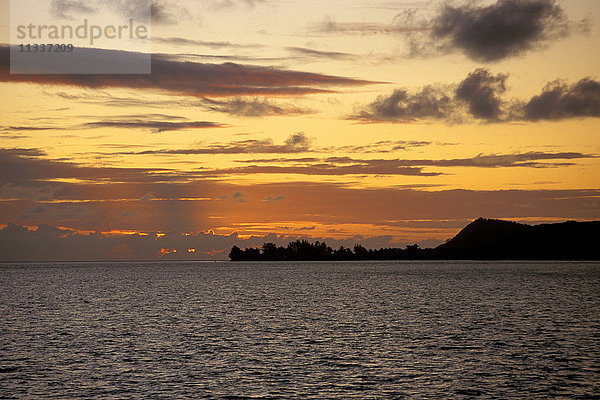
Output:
[{"xmin": 0, "ymin": 0, "xmax": 600, "ymax": 261}]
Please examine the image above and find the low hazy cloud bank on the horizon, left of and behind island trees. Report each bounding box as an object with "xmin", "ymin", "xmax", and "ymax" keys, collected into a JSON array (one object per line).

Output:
[{"xmin": 0, "ymin": 223, "xmax": 394, "ymax": 261}]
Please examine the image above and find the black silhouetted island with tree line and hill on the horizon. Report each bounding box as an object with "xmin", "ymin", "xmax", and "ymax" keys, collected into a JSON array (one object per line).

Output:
[{"xmin": 229, "ymin": 218, "xmax": 600, "ymax": 261}]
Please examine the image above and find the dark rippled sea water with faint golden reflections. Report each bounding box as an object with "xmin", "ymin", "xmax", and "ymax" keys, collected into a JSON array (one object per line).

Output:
[{"xmin": 0, "ymin": 262, "xmax": 600, "ymax": 399}]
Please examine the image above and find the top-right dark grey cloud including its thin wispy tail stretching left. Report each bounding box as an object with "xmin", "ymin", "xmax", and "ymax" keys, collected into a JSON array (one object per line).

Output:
[{"xmin": 310, "ymin": 0, "xmax": 587, "ymax": 62}]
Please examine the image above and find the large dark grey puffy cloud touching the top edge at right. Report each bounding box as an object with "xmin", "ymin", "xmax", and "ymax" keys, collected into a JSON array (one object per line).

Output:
[{"xmin": 418, "ymin": 0, "xmax": 574, "ymax": 62}]
